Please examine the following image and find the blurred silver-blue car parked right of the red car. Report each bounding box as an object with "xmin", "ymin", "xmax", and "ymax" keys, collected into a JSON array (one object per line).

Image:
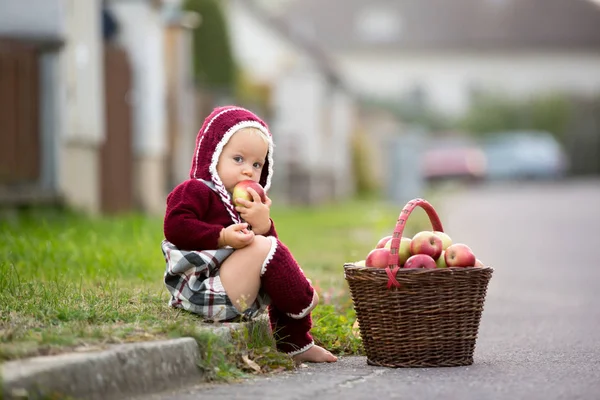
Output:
[{"xmin": 483, "ymin": 131, "xmax": 568, "ymax": 180}]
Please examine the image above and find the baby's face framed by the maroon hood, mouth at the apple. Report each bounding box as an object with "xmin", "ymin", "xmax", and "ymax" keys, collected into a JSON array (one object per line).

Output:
[{"xmin": 217, "ymin": 128, "xmax": 269, "ymax": 193}]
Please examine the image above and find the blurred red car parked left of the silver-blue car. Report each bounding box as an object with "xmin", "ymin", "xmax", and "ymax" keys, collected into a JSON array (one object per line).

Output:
[{"xmin": 421, "ymin": 137, "xmax": 487, "ymax": 182}]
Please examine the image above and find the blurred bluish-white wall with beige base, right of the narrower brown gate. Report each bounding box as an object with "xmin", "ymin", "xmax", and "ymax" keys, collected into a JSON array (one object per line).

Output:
[{"xmin": 109, "ymin": 0, "xmax": 167, "ymax": 214}]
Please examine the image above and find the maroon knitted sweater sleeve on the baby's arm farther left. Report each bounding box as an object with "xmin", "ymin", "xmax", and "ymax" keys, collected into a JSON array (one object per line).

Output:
[{"xmin": 163, "ymin": 180, "xmax": 223, "ymax": 250}]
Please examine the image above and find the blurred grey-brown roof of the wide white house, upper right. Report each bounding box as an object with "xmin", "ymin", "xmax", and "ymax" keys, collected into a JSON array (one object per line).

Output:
[{"xmin": 279, "ymin": 0, "xmax": 600, "ymax": 50}]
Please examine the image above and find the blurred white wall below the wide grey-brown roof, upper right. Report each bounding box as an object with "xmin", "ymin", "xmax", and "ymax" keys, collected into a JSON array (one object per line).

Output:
[{"xmin": 337, "ymin": 51, "xmax": 600, "ymax": 113}]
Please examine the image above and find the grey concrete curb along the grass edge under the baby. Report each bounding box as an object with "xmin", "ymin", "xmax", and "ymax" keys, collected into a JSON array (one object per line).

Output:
[{"xmin": 1, "ymin": 319, "xmax": 268, "ymax": 400}]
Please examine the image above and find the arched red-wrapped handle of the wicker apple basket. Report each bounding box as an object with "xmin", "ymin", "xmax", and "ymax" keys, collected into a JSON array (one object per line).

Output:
[{"xmin": 386, "ymin": 198, "xmax": 444, "ymax": 288}]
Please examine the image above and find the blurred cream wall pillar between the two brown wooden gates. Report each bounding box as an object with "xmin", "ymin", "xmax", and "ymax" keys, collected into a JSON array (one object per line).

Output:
[{"xmin": 58, "ymin": 0, "xmax": 105, "ymax": 212}]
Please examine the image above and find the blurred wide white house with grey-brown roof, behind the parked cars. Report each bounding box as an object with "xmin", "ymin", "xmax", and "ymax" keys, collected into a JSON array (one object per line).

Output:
[{"xmin": 276, "ymin": 0, "xmax": 600, "ymax": 114}]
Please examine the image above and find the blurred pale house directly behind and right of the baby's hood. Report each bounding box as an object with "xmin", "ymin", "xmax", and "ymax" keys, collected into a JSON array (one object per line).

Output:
[{"xmin": 226, "ymin": 0, "xmax": 354, "ymax": 204}]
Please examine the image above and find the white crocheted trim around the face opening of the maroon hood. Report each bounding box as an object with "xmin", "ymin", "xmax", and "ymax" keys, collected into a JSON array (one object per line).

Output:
[{"xmin": 208, "ymin": 119, "xmax": 273, "ymax": 224}]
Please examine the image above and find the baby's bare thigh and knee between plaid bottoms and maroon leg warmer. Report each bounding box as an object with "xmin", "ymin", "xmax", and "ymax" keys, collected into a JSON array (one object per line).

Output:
[{"xmin": 219, "ymin": 235, "xmax": 271, "ymax": 312}]
